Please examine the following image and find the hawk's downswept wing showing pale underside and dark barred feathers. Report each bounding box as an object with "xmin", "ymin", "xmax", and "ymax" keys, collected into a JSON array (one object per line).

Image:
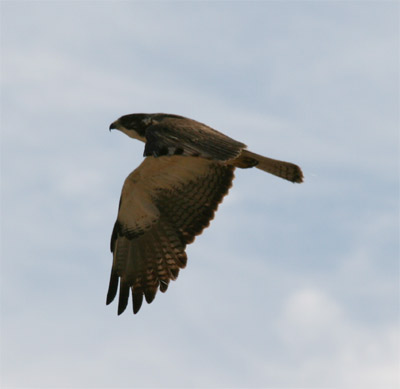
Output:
[{"xmin": 107, "ymin": 156, "xmax": 234, "ymax": 314}]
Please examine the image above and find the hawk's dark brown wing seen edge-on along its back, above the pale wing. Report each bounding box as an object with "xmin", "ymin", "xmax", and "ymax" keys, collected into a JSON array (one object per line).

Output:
[{"xmin": 144, "ymin": 116, "xmax": 246, "ymax": 161}]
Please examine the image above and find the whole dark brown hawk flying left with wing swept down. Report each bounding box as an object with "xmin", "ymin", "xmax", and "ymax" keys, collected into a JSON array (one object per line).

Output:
[{"xmin": 107, "ymin": 113, "xmax": 303, "ymax": 315}]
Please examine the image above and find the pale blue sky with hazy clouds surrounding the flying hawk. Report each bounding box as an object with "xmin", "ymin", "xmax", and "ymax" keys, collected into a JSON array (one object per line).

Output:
[{"xmin": 0, "ymin": 1, "xmax": 400, "ymax": 388}]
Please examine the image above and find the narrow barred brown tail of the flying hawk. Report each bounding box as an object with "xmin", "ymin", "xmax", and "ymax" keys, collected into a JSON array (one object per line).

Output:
[{"xmin": 233, "ymin": 150, "xmax": 303, "ymax": 183}]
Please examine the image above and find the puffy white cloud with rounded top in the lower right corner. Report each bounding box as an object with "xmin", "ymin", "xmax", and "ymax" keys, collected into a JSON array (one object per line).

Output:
[{"xmin": 278, "ymin": 288, "xmax": 400, "ymax": 388}]
